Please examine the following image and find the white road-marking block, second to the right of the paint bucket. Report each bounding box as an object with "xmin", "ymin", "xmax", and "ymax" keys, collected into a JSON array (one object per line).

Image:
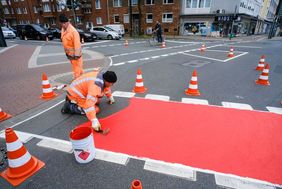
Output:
[{"xmin": 144, "ymin": 159, "xmax": 197, "ymax": 181}]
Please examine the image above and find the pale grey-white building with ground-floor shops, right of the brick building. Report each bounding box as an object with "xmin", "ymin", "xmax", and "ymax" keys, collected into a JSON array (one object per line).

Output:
[{"xmin": 180, "ymin": 0, "xmax": 262, "ymax": 36}]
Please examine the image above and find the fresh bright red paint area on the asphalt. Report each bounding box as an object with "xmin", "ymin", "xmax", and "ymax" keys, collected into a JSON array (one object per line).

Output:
[{"xmin": 78, "ymin": 98, "xmax": 282, "ymax": 184}]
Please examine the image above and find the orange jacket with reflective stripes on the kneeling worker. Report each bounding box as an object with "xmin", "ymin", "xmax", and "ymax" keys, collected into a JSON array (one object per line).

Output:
[{"xmin": 67, "ymin": 71, "xmax": 112, "ymax": 121}]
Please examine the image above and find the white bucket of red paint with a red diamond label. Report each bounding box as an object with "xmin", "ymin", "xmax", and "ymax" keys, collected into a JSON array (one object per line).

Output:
[{"xmin": 69, "ymin": 127, "xmax": 95, "ymax": 163}]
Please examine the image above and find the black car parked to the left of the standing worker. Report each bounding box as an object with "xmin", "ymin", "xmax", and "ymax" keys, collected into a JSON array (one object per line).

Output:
[{"xmin": 17, "ymin": 24, "xmax": 54, "ymax": 40}]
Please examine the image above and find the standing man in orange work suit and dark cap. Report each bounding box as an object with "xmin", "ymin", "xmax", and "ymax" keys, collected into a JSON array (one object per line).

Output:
[{"xmin": 59, "ymin": 14, "xmax": 83, "ymax": 79}]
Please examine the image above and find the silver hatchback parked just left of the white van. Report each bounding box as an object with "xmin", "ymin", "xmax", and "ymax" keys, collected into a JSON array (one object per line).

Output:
[{"xmin": 90, "ymin": 26, "xmax": 121, "ymax": 40}]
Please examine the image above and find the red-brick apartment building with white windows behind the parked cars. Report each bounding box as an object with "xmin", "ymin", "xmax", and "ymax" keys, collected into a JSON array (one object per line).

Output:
[{"xmin": 0, "ymin": 0, "xmax": 180, "ymax": 34}]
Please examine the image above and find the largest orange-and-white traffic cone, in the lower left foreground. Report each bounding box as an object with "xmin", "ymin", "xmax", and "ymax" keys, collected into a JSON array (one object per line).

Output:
[{"xmin": 1, "ymin": 128, "xmax": 45, "ymax": 186}]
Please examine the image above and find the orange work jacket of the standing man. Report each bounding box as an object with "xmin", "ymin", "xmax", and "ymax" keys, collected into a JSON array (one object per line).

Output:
[{"xmin": 61, "ymin": 23, "xmax": 82, "ymax": 60}]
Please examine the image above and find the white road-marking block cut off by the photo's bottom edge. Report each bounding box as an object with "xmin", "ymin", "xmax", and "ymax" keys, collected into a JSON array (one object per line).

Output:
[{"xmin": 215, "ymin": 174, "xmax": 275, "ymax": 189}]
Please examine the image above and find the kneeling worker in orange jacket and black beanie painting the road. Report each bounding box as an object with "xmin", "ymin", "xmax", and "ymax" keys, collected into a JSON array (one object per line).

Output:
[{"xmin": 61, "ymin": 71, "xmax": 117, "ymax": 132}]
